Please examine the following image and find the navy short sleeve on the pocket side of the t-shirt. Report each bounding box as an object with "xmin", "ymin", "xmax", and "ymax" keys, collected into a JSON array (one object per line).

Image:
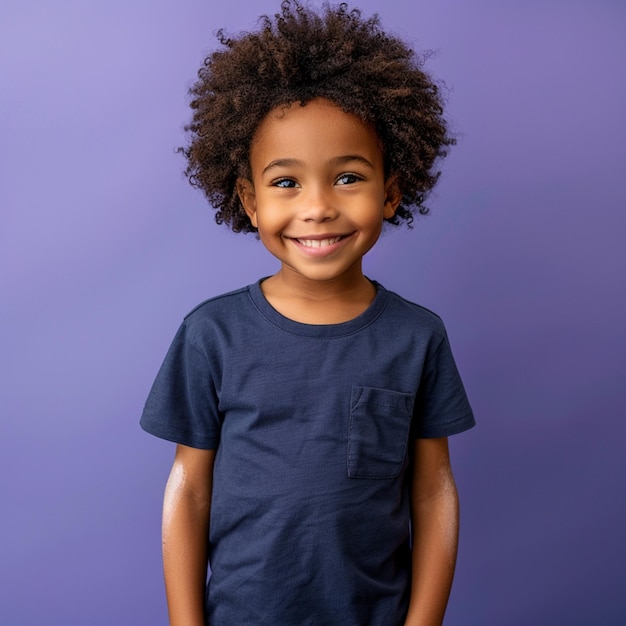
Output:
[{"xmin": 414, "ymin": 331, "xmax": 476, "ymax": 438}]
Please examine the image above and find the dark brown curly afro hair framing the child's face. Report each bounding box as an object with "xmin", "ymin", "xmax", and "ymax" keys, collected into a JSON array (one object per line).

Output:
[{"xmin": 179, "ymin": 0, "xmax": 455, "ymax": 232}]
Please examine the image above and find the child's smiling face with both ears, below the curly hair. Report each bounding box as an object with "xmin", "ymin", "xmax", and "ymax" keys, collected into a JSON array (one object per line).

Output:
[{"xmin": 239, "ymin": 99, "xmax": 400, "ymax": 281}]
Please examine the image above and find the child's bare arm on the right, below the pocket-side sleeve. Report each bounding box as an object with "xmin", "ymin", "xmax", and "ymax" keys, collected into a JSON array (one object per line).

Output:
[{"xmin": 405, "ymin": 438, "xmax": 459, "ymax": 626}]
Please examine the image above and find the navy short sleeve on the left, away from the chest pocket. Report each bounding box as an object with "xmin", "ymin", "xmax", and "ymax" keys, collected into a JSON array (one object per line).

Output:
[{"xmin": 140, "ymin": 321, "xmax": 221, "ymax": 450}]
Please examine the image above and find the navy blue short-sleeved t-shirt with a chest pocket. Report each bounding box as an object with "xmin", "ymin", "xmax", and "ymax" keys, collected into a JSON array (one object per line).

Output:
[{"xmin": 141, "ymin": 282, "xmax": 474, "ymax": 626}]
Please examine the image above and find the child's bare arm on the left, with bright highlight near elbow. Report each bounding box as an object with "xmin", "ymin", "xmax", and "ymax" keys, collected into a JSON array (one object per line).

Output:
[{"xmin": 163, "ymin": 444, "xmax": 215, "ymax": 626}]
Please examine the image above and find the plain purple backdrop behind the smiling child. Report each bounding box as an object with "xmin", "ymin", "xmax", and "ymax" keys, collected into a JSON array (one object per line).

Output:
[{"xmin": 0, "ymin": 0, "xmax": 626, "ymax": 626}]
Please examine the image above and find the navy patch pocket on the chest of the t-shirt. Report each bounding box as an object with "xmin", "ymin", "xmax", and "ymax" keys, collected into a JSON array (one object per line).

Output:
[{"xmin": 348, "ymin": 386, "xmax": 414, "ymax": 478}]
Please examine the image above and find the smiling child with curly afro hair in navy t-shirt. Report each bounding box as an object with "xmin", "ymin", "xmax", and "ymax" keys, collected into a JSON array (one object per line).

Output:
[{"xmin": 141, "ymin": 1, "xmax": 474, "ymax": 626}]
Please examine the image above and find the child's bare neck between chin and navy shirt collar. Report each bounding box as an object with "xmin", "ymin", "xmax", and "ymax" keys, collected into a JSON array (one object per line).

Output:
[{"xmin": 261, "ymin": 268, "xmax": 376, "ymax": 324}]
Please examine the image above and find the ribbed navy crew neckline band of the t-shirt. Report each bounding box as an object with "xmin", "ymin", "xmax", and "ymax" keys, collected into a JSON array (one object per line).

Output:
[{"xmin": 248, "ymin": 278, "xmax": 389, "ymax": 339}]
